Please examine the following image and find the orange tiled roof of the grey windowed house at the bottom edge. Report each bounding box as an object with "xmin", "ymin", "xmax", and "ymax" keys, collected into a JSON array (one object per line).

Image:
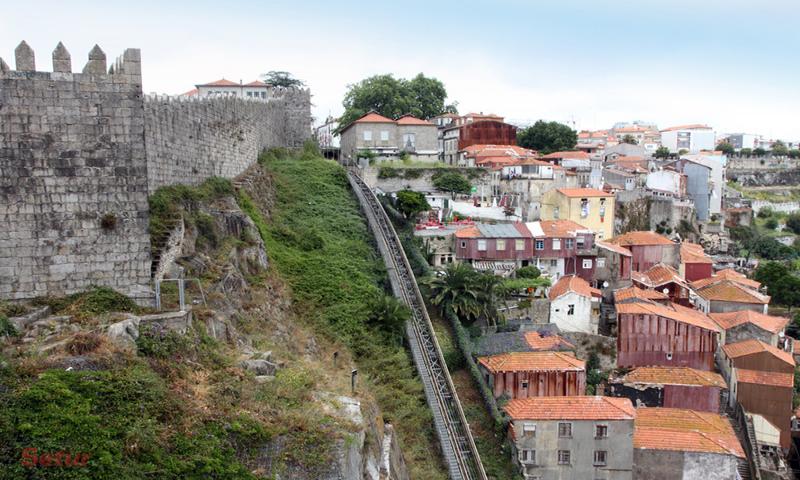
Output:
[{"xmin": 503, "ymin": 396, "xmax": 637, "ymax": 420}]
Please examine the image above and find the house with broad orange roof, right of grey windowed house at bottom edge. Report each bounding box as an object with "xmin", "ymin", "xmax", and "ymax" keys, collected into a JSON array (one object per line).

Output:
[{"xmin": 633, "ymin": 408, "xmax": 746, "ymax": 480}]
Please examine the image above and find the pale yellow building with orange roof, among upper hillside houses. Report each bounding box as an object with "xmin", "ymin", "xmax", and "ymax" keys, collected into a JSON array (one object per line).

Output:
[{"xmin": 541, "ymin": 188, "xmax": 614, "ymax": 240}]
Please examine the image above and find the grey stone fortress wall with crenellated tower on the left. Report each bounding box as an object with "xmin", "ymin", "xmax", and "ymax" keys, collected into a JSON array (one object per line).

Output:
[{"xmin": 0, "ymin": 42, "xmax": 311, "ymax": 299}]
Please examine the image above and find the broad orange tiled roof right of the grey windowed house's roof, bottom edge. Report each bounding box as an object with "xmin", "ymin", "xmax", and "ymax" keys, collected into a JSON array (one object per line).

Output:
[{"xmin": 633, "ymin": 408, "xmax": 745, "ymax": 458}]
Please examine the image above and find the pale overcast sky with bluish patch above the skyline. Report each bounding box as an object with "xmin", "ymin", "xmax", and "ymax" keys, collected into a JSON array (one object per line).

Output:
[{"xmin": 0, "ymin": 0, "xmax": 800, "ymax": 140}]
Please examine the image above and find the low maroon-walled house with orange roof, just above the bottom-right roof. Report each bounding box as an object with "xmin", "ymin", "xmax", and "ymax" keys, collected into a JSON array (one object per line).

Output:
[{"xmin": 606, "ymin": 367, "xmax": 727, "ymax": 413}]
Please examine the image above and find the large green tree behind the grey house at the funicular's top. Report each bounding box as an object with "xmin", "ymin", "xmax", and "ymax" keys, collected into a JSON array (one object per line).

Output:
[{"xmin": 339, "ymin": 73, "xmax": 456, "ymax": 127}]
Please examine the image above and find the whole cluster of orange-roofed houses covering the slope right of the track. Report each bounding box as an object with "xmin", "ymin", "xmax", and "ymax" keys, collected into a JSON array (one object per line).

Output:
[{"xmin": 326, "ymin": 112, "xmax": 800, "ymax": 480}]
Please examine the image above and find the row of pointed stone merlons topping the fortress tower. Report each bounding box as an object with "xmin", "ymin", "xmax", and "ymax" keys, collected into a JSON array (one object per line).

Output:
[{"xmin": 0, "ymin": 40, "xmax": 142, "ymax": 79}]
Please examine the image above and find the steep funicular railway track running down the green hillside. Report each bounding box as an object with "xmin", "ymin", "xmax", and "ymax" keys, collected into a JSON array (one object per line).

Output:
[{"xmin": 348, "ymin": 170, "xmax": 486, "ymax": 480}]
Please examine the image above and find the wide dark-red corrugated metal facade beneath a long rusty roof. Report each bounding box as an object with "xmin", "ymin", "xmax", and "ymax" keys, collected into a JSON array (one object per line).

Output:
[{"xmin": 617, "ymin": 313, "xmax": 717, "ymax": 370}]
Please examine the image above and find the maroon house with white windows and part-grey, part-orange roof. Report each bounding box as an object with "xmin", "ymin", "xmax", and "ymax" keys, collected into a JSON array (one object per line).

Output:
[{"xmin": 455, "ymin": 223, "xmax": 533, "ymax": 273}]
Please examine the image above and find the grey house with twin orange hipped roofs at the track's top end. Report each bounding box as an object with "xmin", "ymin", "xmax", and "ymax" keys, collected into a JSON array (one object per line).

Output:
[{"xmin": 340, "ymin": 112, "xmax": 439, "ymax": 163}]
